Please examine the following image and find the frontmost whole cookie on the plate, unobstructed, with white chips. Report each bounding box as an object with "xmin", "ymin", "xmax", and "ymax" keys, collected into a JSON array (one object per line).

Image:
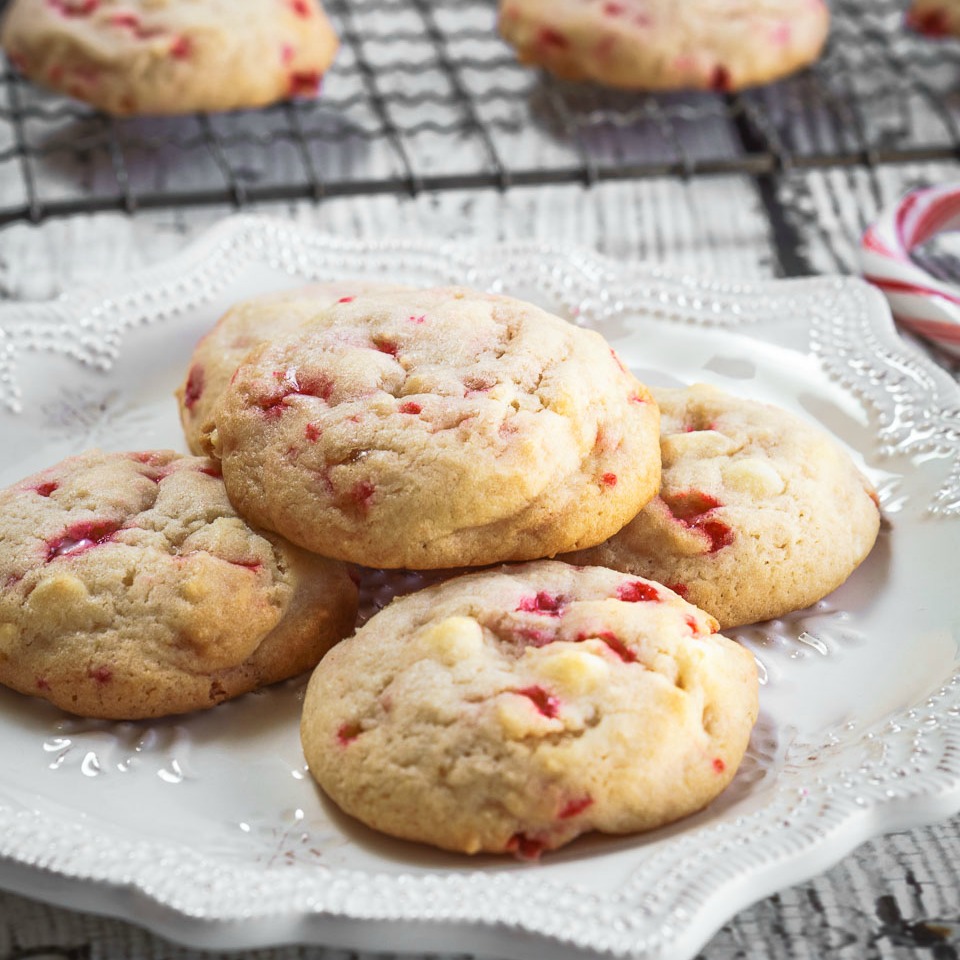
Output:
[{"xmin": 301, "ymin": 560, "xmax": 757, "ymax": 856}]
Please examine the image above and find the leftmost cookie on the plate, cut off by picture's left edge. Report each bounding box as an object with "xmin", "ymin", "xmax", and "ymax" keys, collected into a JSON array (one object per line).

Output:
[{"xmin": 0, "ymin": 450, "xmax": 357, "ymax": 720}]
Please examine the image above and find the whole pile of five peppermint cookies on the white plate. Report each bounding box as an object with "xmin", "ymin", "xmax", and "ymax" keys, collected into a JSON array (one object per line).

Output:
[{"xmin": 0, "ymin": 283, "xmax": 879, "ymax": 857}]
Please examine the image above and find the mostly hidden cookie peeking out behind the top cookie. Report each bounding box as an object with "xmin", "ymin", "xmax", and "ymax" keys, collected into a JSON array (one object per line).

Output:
[{"xmin": 176, "ymin": 281, "xmax": 401, "ymax": 456}]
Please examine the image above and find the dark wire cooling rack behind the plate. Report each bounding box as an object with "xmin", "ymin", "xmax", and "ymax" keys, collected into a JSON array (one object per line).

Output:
[{"xmin": 0, "ymin": 0, "xmax": 960, "ymax": 231}]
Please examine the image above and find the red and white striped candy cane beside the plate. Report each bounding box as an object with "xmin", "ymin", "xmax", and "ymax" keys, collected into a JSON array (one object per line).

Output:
[{"xmin": 860, "ymin": 184, "xmax": 960, "ymax": 357}]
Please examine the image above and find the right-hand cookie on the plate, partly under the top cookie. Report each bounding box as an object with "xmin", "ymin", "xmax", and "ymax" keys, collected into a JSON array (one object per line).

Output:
[{"xmin": 567, "ymin": 384, "xmax": 880, "ymax": 628}]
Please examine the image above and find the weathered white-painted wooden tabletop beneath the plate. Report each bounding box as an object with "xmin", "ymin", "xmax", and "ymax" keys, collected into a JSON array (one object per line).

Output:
[{"xmin": 0, "ymin": 164, "xmax": 960, "ymax": 960}]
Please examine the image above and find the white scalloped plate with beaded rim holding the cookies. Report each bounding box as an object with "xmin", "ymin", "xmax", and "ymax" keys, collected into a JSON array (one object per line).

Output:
[{"xmin": 0, "ymin": 217, "xmax": 960, "ymax": 960}]
